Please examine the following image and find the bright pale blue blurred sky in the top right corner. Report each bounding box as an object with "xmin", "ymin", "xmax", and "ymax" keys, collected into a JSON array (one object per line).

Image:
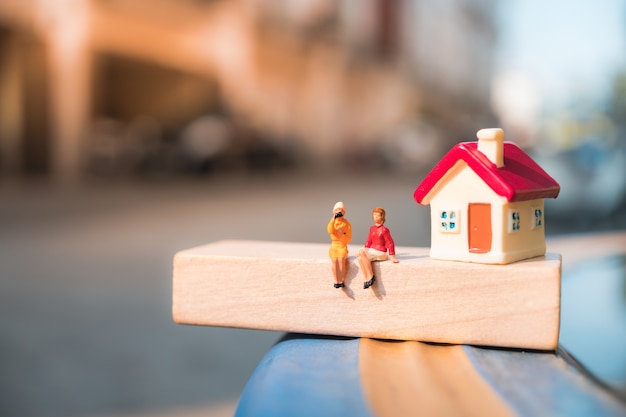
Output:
[{"xmin": 497, "ymin": 0, "xmax": 626, "ymax": 107}]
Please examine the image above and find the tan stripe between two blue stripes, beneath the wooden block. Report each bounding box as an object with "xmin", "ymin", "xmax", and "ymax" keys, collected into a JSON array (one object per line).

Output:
[{"xmin": 359, "ymin": 339, "xmax": 514, "ymax": 417}]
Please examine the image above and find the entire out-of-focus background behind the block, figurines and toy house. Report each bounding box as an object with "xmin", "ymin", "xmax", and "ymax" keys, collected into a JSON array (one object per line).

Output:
[{"xmin": 0, "ymin": 0, "xmax": 626, "ymax": 417}]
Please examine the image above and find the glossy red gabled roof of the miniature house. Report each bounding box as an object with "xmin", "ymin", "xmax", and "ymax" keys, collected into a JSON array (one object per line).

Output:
[{"xmin": 413, "ymin": 142, "xmax": 561, "ymax": 204}]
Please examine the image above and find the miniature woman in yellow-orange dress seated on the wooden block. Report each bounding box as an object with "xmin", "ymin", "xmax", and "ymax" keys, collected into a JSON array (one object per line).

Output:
[{"xmin": 326, "ymin": 201, "xmax": 352, "ymax": 288}]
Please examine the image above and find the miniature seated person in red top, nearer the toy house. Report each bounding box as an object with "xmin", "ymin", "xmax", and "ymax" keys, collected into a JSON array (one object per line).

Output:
[{"xmin": 359, "ymin": 207, "xmax": 399, "ymax": 289}]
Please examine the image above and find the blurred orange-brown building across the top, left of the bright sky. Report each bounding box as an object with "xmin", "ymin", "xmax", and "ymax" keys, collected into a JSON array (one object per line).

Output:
[{"xmin": 0, "ymin": 0, "xmax": 496, "ymax": 179}]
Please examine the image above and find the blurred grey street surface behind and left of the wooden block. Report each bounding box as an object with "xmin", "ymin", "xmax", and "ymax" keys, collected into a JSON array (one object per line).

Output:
[{"xmin": 0, "ymin": 173, "xmax": 429, "ymax": 417}]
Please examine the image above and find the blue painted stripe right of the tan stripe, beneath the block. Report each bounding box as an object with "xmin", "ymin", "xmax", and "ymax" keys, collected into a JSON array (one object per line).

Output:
[{"xmin": 463, "ymin": 346, "xmax": 626, "ymax": 417}]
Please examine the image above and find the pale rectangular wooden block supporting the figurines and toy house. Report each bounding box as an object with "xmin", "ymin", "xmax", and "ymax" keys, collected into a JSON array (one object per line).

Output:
[{"xmin": 173, "ymin": 241, "xmax": 561, "ymax": 350}]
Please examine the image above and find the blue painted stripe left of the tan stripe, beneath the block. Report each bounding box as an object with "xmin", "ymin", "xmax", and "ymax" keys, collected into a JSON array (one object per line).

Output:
[{"xmin": 235, "ymin": 335, "xmax": 374, "ymax": 417}]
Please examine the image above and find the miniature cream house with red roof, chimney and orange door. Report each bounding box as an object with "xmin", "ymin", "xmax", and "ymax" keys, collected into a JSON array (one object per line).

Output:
[{"xmin": 414, "ymin": 129, "xmax": 560, "ymax": 264}]
